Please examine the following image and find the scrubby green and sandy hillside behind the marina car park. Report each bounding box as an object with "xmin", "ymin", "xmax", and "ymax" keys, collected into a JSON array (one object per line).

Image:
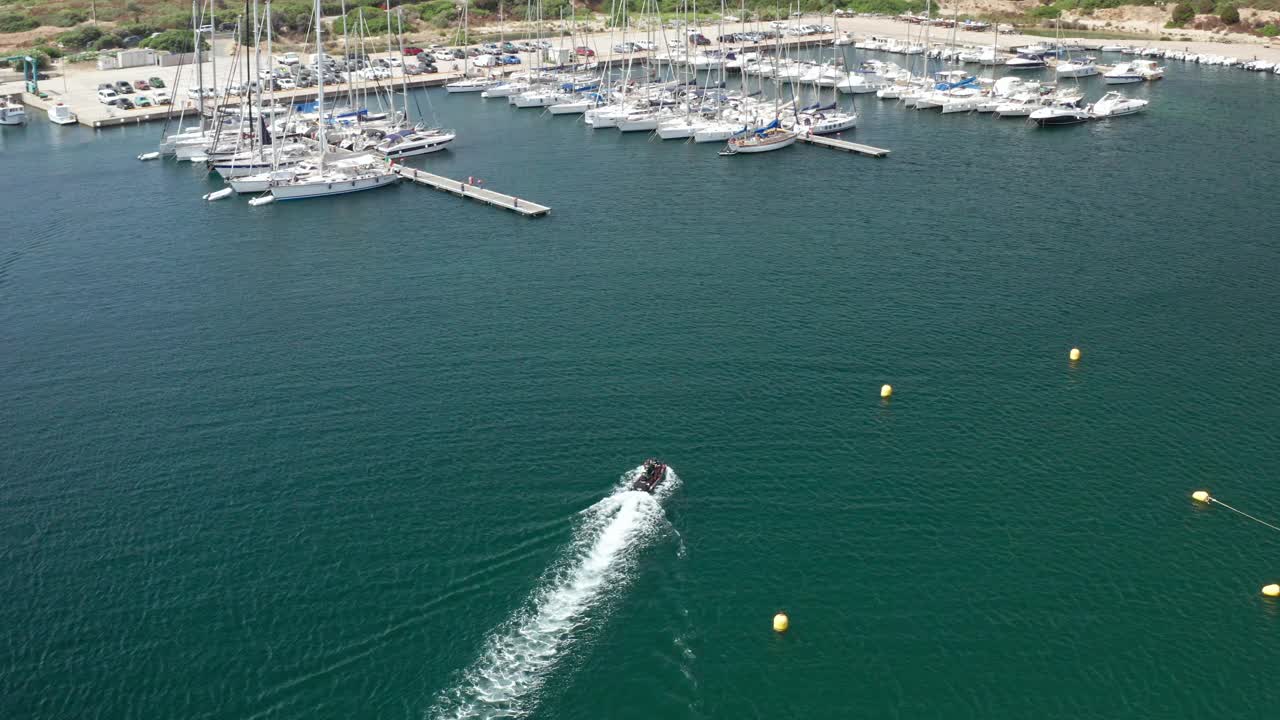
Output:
[{"xmin": 0, "ymin": 0, "xmax": 1280, "ymax": 56}]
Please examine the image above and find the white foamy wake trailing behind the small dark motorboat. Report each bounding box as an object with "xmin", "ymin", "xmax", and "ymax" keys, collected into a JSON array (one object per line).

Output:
[{"xmin": 428, "ymin": 468, "xmax": 680, "ymax": 720}]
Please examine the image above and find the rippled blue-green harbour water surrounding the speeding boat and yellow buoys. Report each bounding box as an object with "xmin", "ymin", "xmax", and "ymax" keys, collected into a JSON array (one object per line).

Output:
[{"xmin": 0, "ymin": 57, "xmax": 1280, "ymax": 719}]
